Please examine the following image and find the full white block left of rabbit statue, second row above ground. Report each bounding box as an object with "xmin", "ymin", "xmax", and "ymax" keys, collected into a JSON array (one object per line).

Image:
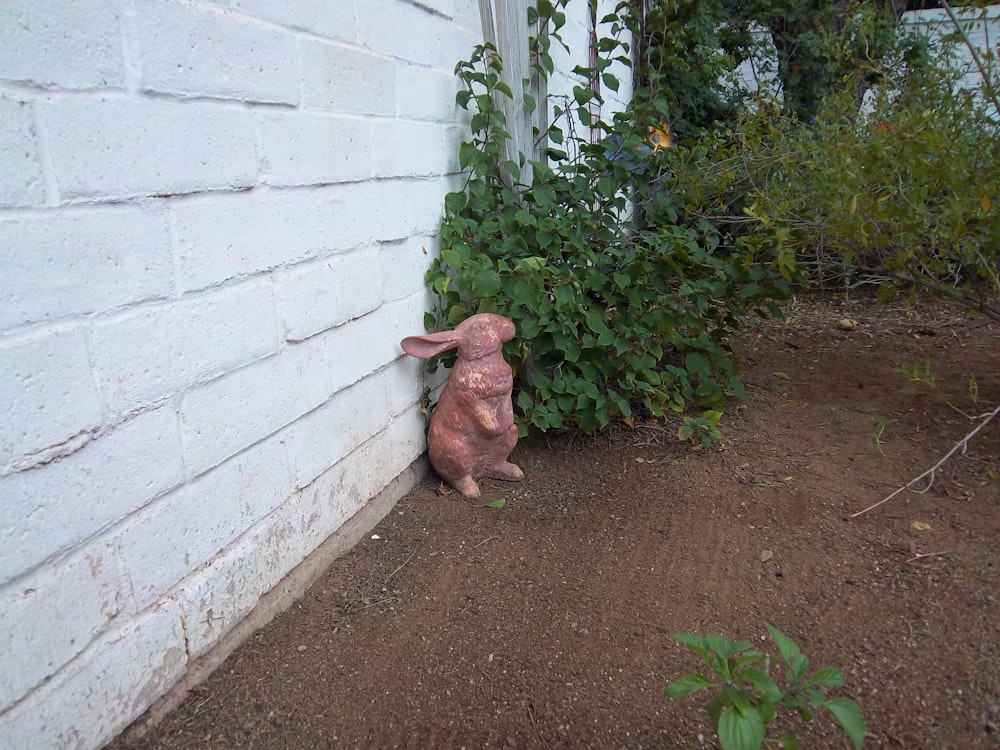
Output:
[{"xmin": 285, "ymin": 374, "xmax": 389, "ymax": 487}]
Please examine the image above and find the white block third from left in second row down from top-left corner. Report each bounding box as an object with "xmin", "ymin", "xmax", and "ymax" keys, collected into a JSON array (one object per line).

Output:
[{"xmin": 261, "ymin": 112, "xmax": 373, "ymax": 186}]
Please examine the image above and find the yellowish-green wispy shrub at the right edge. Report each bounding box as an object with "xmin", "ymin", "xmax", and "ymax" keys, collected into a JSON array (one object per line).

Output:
[{"xmin": 679, "ymin": 5, "xmax": 1000, "ymax": 319}]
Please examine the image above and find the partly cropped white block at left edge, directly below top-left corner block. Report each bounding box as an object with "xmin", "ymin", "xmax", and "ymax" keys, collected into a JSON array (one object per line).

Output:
[{"xmin": 0, "ymin": 97, "xmax": 45, "ymax": 206}]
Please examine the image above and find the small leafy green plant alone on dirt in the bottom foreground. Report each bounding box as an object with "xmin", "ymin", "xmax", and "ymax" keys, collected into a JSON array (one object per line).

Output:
[{"xmin": 664, "ymin": 624, "xmax": 866, "ymax": 750}]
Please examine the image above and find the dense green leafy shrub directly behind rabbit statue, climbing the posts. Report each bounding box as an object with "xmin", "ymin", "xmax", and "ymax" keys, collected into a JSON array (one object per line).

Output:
[{"xmin": 426, "ymin": 23, "xmax": 784, "ymax": 432}]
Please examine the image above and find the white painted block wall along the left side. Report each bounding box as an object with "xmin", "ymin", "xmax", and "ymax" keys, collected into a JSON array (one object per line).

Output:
[{"xmin": 0, "ymin": 0, "xmax": 632, "ymax": 749}]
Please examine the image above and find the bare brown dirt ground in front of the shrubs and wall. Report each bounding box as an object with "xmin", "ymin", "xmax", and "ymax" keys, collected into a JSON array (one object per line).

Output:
[{"xmin": 113, "ymin": 297, "xmax": 1000, "ymax": 750}]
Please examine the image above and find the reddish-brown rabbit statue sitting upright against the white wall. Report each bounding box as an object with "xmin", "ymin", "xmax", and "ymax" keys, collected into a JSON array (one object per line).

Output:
[{"xmin": 400, "ymin": 313, "xmax": 524, "ymax": 497}]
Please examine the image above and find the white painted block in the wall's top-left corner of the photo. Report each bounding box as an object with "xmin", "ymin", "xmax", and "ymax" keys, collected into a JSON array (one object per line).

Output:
[{"xmin": 0, "ymin": 0, "xmax": 124, "ymax": 89}]
